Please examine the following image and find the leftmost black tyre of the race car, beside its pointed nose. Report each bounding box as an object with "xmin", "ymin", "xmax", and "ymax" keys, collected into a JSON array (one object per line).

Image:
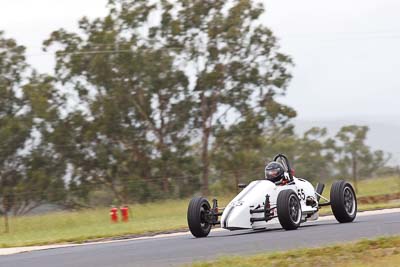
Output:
[{"xmin": 187, "ymin": 197, "xmax": 211, "ymax": 237}]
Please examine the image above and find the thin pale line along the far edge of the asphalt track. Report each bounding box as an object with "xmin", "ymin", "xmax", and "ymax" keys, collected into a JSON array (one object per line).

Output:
[{"xmin": 0, "ymin": 208, "xmax": 400, "ymax": 256}]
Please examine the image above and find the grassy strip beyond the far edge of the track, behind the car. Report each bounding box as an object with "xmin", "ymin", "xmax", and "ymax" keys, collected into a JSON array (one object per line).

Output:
[{"xmin": 0, "ymin": 177, "xmax": 400, "ymax": 247}]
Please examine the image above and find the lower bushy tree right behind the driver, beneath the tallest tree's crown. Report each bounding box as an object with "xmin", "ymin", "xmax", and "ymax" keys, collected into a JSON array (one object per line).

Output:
[{"xmin": 212, "ymin": 102, "xmax": 296, "ymax": 191}]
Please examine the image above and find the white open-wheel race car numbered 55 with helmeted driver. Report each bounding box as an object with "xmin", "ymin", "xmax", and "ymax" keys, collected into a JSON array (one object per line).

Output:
[{"xmin": 187, "ymin": 154, "xmax": 357, "ymax": 237}]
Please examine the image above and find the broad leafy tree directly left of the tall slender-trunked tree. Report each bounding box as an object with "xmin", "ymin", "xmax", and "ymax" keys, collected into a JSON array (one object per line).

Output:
[{"xmin": 45, "ymin": 13, "xmax": 194, "ymax": 202}]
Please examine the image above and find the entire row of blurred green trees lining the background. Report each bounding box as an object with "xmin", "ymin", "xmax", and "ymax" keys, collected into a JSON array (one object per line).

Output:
[{"xmin": 0, "ymin": 0, "xmax": 394, "ymax": 213}]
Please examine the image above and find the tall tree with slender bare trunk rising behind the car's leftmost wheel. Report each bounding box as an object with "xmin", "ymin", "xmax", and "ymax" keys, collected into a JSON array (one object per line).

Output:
[{"xmin": 112, "ymin": 0, "xmax": 291, "ymax": 195}]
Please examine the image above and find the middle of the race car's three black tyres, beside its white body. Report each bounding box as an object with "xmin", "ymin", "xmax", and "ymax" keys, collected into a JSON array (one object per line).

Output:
[{"xmin": 276, "ymin": 189, "xmax": 301, "ymax": 230}]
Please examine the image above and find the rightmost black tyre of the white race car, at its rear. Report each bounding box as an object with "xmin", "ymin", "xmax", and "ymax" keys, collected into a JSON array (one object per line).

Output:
[{"xmin": 331, "ymin": 180, "xmax": 357, "ymax": 223}]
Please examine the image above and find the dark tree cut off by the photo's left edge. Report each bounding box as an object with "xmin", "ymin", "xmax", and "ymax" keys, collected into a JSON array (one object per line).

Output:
[{"xmin": 0, "ymin": 32, "xmax": 32, "ymax": 231}]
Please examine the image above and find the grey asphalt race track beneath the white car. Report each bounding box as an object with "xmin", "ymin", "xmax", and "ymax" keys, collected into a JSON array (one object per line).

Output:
[{"xmin": 0, "ymin": 212, "xmax": 400, "ymax": 267}]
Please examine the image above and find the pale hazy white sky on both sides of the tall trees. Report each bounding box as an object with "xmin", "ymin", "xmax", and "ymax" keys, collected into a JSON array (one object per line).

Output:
[{"xmin": 0, "ymin": 0, "xmax": 400, "ymax": 121}]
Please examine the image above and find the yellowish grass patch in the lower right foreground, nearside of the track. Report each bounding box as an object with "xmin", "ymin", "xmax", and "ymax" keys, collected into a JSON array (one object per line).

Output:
[{"xmin": 192, "ymin": 236, "xmax": 400, "ymax": 267}]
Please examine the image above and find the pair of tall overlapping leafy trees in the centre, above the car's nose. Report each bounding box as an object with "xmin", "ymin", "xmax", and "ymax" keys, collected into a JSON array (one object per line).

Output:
[{"xmin": 44, "ymin": 0, "xmax": 295, "ymax": 203}]
